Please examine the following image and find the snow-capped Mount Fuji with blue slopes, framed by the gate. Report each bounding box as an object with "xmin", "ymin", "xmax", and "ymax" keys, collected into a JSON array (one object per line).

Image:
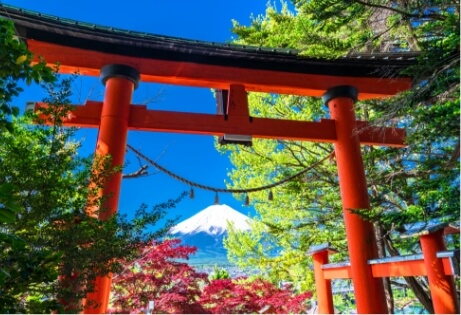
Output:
[{"xmin": 169, "ymin": 204, "xmax": 251, "ymax": 266}]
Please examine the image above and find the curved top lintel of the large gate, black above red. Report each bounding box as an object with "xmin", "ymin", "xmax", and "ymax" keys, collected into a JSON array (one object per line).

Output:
[{"xmin": 0, "ymin": 4, "xmax": 417, "ymax": 99}]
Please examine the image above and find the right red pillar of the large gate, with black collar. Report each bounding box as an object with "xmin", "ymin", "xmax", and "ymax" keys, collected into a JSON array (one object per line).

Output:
[{"xmin": 322, "ymin": 86, "xmax": 388, "ymax": 314}]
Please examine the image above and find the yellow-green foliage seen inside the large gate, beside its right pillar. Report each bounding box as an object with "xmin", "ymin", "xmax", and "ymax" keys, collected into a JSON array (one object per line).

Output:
[{"xmin": 221, "ymin": 93, "xmax": 347, "ymax": 290}]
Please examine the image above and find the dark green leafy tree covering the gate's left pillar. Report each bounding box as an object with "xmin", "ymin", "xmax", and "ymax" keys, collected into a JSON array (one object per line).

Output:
[{"xmin": 0, "ymin": 20, "xmax": 182, "ymax": 313}]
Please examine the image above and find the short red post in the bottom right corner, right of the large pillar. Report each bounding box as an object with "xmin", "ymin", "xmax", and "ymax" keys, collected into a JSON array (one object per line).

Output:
[{"xmin": 420, "ymin": 229, "xmax": 459, "ymax": 314}]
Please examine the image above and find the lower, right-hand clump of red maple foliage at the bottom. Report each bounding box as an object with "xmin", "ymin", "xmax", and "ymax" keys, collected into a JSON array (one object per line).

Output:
[{"xmin": 200, "ymin": 279, "xmax": 312, "ymax": 314}]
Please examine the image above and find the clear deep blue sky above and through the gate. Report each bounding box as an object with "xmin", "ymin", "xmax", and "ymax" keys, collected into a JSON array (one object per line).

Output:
[{"xmin": 3, "ymin": 0, "xmax": 274, "ymax": 225}]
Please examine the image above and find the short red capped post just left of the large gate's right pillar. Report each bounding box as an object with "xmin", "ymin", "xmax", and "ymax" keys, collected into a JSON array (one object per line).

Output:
[{"xmin": 308, "ymin": 243, "xmax": 336, "ymax": 314}]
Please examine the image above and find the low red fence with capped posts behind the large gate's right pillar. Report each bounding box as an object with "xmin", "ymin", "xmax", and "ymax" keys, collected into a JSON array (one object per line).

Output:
[{"xmin": 307, "ymin": 223, "xmax": 459, "ymax": 314}]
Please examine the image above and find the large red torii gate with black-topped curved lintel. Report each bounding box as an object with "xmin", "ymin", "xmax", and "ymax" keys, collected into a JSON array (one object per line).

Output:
[{"xmin": 1, "ymin": 5, "xmax": 446, "ymax": 313}]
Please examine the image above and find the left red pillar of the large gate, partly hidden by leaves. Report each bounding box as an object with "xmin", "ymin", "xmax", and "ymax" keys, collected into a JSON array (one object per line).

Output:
[{"xmin": 84, "ymin": 65, "xmax": 140, "ymax": 314}]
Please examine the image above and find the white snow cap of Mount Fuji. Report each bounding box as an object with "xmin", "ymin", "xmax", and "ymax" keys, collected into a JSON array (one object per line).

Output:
[{"xmin": 170, "ymin": 204, "xmax": 251, "ymax": 235}]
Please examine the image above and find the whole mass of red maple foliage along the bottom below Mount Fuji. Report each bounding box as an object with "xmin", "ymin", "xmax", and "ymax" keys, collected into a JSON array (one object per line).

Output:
[{"xmin": 109, "ymin": 239, "xmax": 312, "ymax": 314}]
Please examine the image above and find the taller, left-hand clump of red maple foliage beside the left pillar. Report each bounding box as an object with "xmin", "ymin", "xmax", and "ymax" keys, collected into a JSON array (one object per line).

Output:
[{"xmin": 110, "ymin": 239, "xmax": 208, "ymax": 314}]
